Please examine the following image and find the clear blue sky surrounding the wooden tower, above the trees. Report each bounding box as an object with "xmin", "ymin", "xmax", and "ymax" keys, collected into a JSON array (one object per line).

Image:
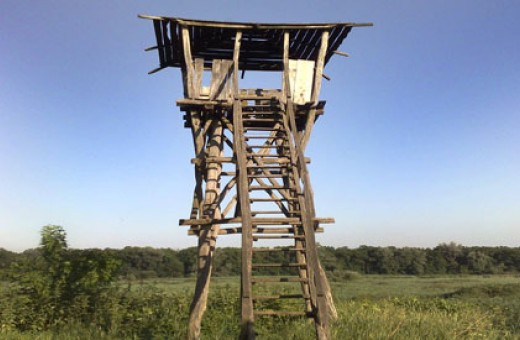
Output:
[{"xmin": 0, "ymin": 0, "xmax": 520, "ymax": 251}]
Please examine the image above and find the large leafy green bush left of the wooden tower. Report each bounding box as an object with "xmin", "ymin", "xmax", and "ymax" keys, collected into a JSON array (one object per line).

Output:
[{"xmin": 1, "ymin": 225, "xmax": 118, "ymax": 331}]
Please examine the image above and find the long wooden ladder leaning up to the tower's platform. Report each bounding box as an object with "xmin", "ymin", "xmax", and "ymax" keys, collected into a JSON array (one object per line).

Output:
[{"xmin": 233, "ymin": 96, "xmax": 329, "ymax": 339}]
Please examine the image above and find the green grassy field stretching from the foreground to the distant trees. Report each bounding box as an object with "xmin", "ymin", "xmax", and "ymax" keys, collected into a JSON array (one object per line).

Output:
[{"xmin": 0, "ymin": 276, "xmax": 520, "ymax": 339}]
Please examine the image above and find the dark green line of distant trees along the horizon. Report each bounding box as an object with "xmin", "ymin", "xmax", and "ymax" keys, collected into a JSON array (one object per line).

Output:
[{"xmin": 0, "ymin": 242, "xmax": 520, "ymax": 279}]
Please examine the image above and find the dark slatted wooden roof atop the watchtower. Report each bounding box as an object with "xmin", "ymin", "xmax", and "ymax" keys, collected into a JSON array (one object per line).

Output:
[{"xmin": 139, "ymin": 15, "xmax": 372, "ymax": 71}]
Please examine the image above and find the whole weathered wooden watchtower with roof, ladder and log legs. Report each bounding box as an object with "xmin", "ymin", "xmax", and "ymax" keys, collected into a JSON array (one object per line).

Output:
[{"xmin": 140, "ymin": 16, "xmax": 371, "ymax": 339}]
